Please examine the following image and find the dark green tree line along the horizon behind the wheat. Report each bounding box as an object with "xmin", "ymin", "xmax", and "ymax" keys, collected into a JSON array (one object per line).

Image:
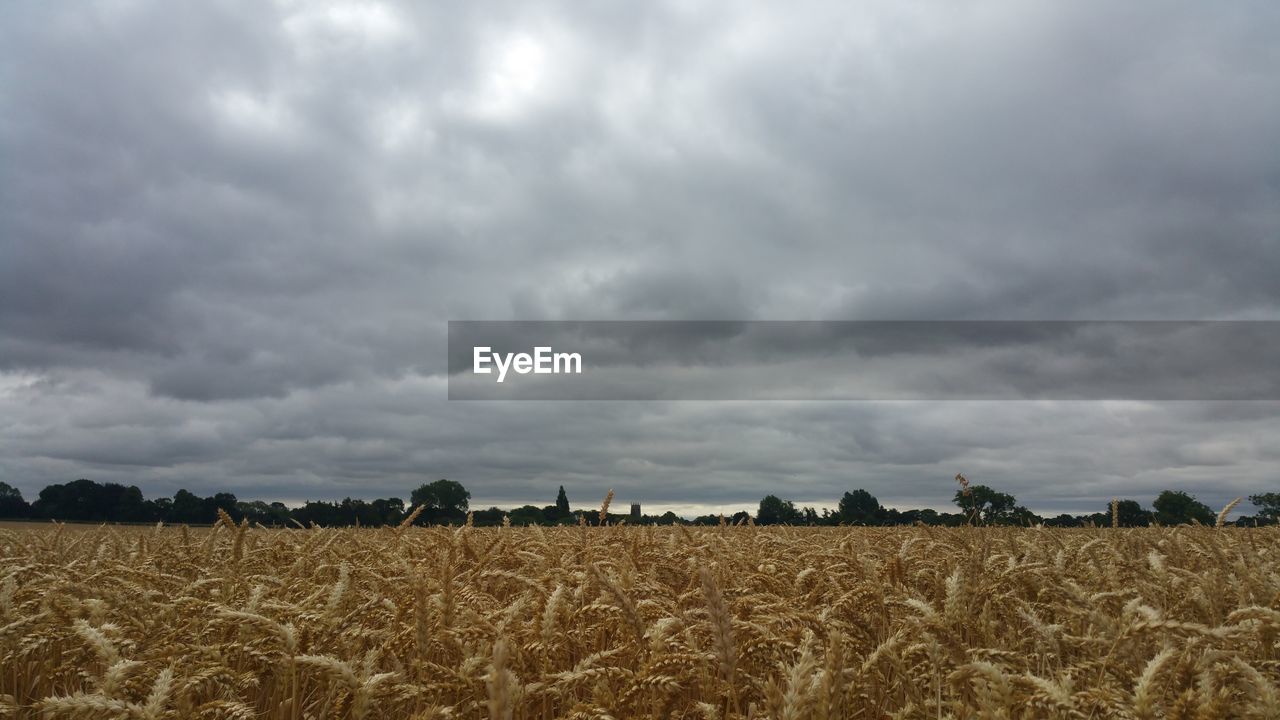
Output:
[{"xmin": 0, "ymin": 475, "xmax": 1280, "ymax": 528}]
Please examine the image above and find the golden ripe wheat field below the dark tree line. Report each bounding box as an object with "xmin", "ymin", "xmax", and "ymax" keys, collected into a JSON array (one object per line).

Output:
[{"xmin": 0, "ymin": 523, "xmax": 1280, "ymax": 719}]
